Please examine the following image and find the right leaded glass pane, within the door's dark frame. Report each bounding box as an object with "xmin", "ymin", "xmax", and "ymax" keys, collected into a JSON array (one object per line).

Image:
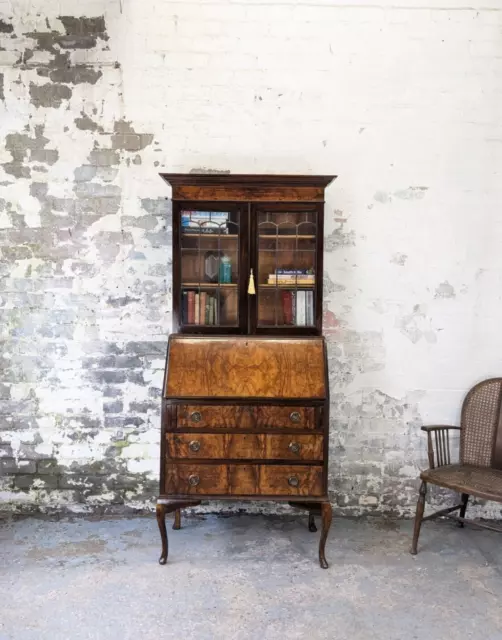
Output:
[{"xmin": 257, "ymin": 211, "xmax": 317, "ymax": 327}]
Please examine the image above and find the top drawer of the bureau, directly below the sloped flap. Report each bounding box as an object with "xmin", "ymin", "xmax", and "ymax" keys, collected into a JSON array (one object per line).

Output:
[{"xmin": 177, "ymin": 404, "xmax": 316, "ymax": 429}]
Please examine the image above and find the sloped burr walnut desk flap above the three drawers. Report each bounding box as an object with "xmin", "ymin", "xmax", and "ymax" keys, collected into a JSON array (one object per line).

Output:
[{"xmin": 164, "ymin": 335, "xmax": 327, "ymax": 400}]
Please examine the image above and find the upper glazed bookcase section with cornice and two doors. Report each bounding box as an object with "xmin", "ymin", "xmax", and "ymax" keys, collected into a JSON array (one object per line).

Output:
[{"xmin": 160, "ymin": 173, "xmax": 335, "ymax": 336}]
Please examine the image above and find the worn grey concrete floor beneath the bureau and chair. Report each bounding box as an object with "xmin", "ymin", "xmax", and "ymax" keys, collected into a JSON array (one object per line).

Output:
[{"xmin": 0, "ymin": 515, "xmax": 502, "ymax": 640}]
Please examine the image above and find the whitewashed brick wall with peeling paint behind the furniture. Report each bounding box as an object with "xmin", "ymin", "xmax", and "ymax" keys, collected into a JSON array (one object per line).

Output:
[{"xmin": 0, "ymin": 0, "xmax": 502, "ymax": 515}]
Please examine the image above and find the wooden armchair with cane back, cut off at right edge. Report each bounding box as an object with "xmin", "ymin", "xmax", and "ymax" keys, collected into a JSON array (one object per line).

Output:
[{"xmin": 411, "ymin": 378, "xmax": 502, "ymax": 555}]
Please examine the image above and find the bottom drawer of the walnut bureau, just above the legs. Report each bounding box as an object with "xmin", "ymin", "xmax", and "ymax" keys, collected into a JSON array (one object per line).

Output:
[{"xmin": 166, "ymin": 462, "xmax": 323, "ymax": 497}]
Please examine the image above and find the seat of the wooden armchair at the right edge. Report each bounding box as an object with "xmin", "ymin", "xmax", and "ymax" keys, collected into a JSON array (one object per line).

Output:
[{"xmin": 420, "ymin": 464, "xmax": 502, "ymax": 502}]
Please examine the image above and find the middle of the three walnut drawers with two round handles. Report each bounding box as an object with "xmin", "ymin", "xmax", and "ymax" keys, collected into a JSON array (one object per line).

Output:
[{"xmin": 166, "ymin": 433, "xmax": 323, "ymax": 461}]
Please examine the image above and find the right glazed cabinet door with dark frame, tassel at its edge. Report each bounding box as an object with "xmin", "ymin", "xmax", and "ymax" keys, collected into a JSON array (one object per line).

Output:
[{"xmin": 250, "ymin": 203, "xmax": 323, "ymax": 335}]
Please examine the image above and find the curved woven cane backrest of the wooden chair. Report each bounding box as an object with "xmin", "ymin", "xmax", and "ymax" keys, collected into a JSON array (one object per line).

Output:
[{"xmin": 460, "ymin": 378, "xmax": 502, "ymax": 469}]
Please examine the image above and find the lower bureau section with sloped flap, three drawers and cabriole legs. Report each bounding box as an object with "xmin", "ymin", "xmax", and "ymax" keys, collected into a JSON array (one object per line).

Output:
[{"xmin": 157, "ymin": 335, "xmax": 331, "ymax": 568}]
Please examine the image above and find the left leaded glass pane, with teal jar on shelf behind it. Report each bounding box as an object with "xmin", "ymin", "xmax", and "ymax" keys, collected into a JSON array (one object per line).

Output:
[{"xmin": 180, "ymin": 209, "xmax": 240, "ymax": 327}]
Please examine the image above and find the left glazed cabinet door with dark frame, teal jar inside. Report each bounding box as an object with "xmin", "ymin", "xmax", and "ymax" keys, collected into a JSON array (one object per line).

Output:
[{"xmin": 173, "ymin": 202, "xmax": 249, "ymax": 334}]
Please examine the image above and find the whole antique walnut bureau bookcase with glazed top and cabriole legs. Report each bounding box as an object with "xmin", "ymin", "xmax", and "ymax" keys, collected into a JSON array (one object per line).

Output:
[{"xmin": 157, "ymin": 174, "xmax": 335, "ymax": 568}]
